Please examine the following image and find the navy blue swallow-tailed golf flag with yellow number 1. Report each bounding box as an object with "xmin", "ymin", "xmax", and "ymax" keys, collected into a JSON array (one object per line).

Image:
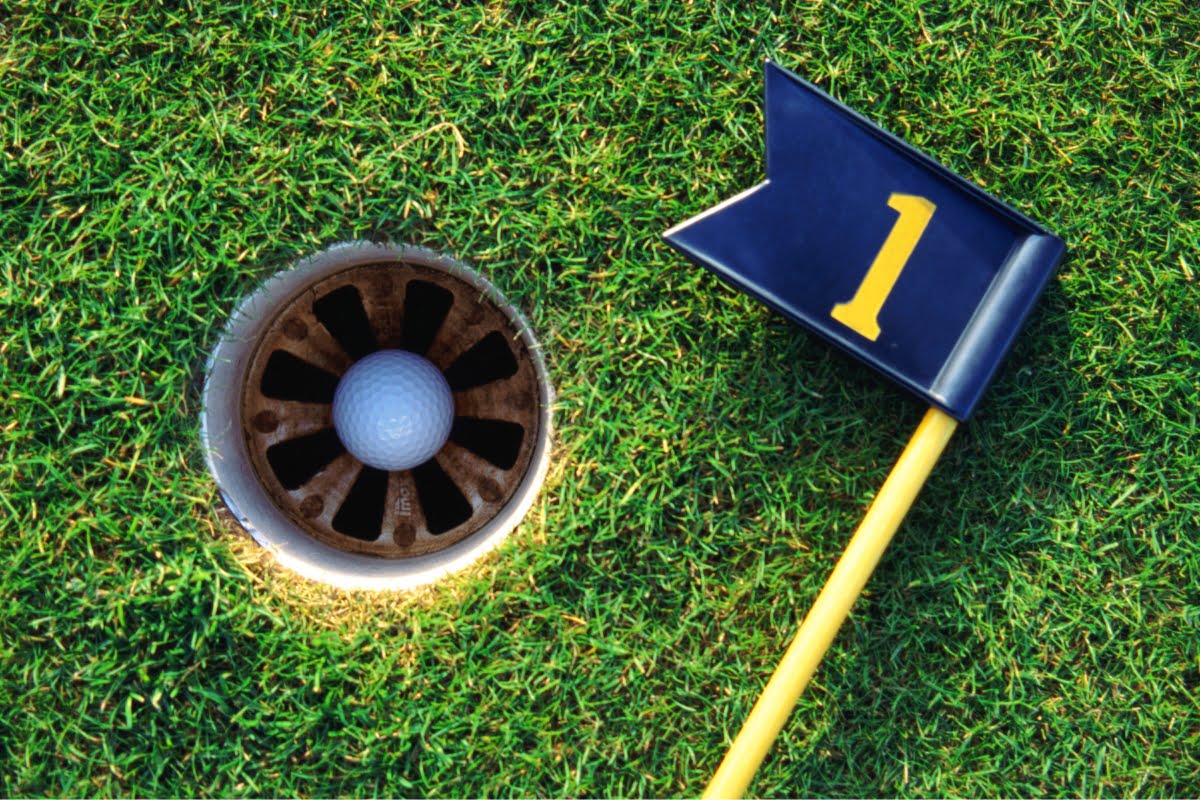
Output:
[{"xmin": 664, "ymin": 61, "xmax": 1064, "ymax": 420}]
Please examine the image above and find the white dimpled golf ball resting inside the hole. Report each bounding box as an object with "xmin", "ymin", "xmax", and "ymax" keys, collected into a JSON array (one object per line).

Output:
[{"xmin": 334, "ymin": 350, "xmax": 454, "ymax": 471}]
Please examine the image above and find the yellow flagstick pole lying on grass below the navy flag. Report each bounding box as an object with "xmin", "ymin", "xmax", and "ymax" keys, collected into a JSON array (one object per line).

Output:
[{"xmin": 704, "ymin": 408, "xmax": 958, "ymax": 800}]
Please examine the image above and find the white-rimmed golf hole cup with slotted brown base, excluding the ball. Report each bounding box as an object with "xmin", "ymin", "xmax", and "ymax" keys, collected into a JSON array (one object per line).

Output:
[{"xmin": 200, "ymin": 242, "xmax": 552, "ymax": 589}]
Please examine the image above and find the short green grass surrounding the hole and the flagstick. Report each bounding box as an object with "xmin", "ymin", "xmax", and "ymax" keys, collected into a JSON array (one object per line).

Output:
[{"xmin": 0, "ymin": 0, "xmax": 1200, "ymax": 796}]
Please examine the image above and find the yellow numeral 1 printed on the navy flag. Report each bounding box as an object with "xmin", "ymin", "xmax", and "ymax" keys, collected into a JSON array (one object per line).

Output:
[{"xmin": 830, "ymin": 193, "xmax": 937, "ymax": 342}]
